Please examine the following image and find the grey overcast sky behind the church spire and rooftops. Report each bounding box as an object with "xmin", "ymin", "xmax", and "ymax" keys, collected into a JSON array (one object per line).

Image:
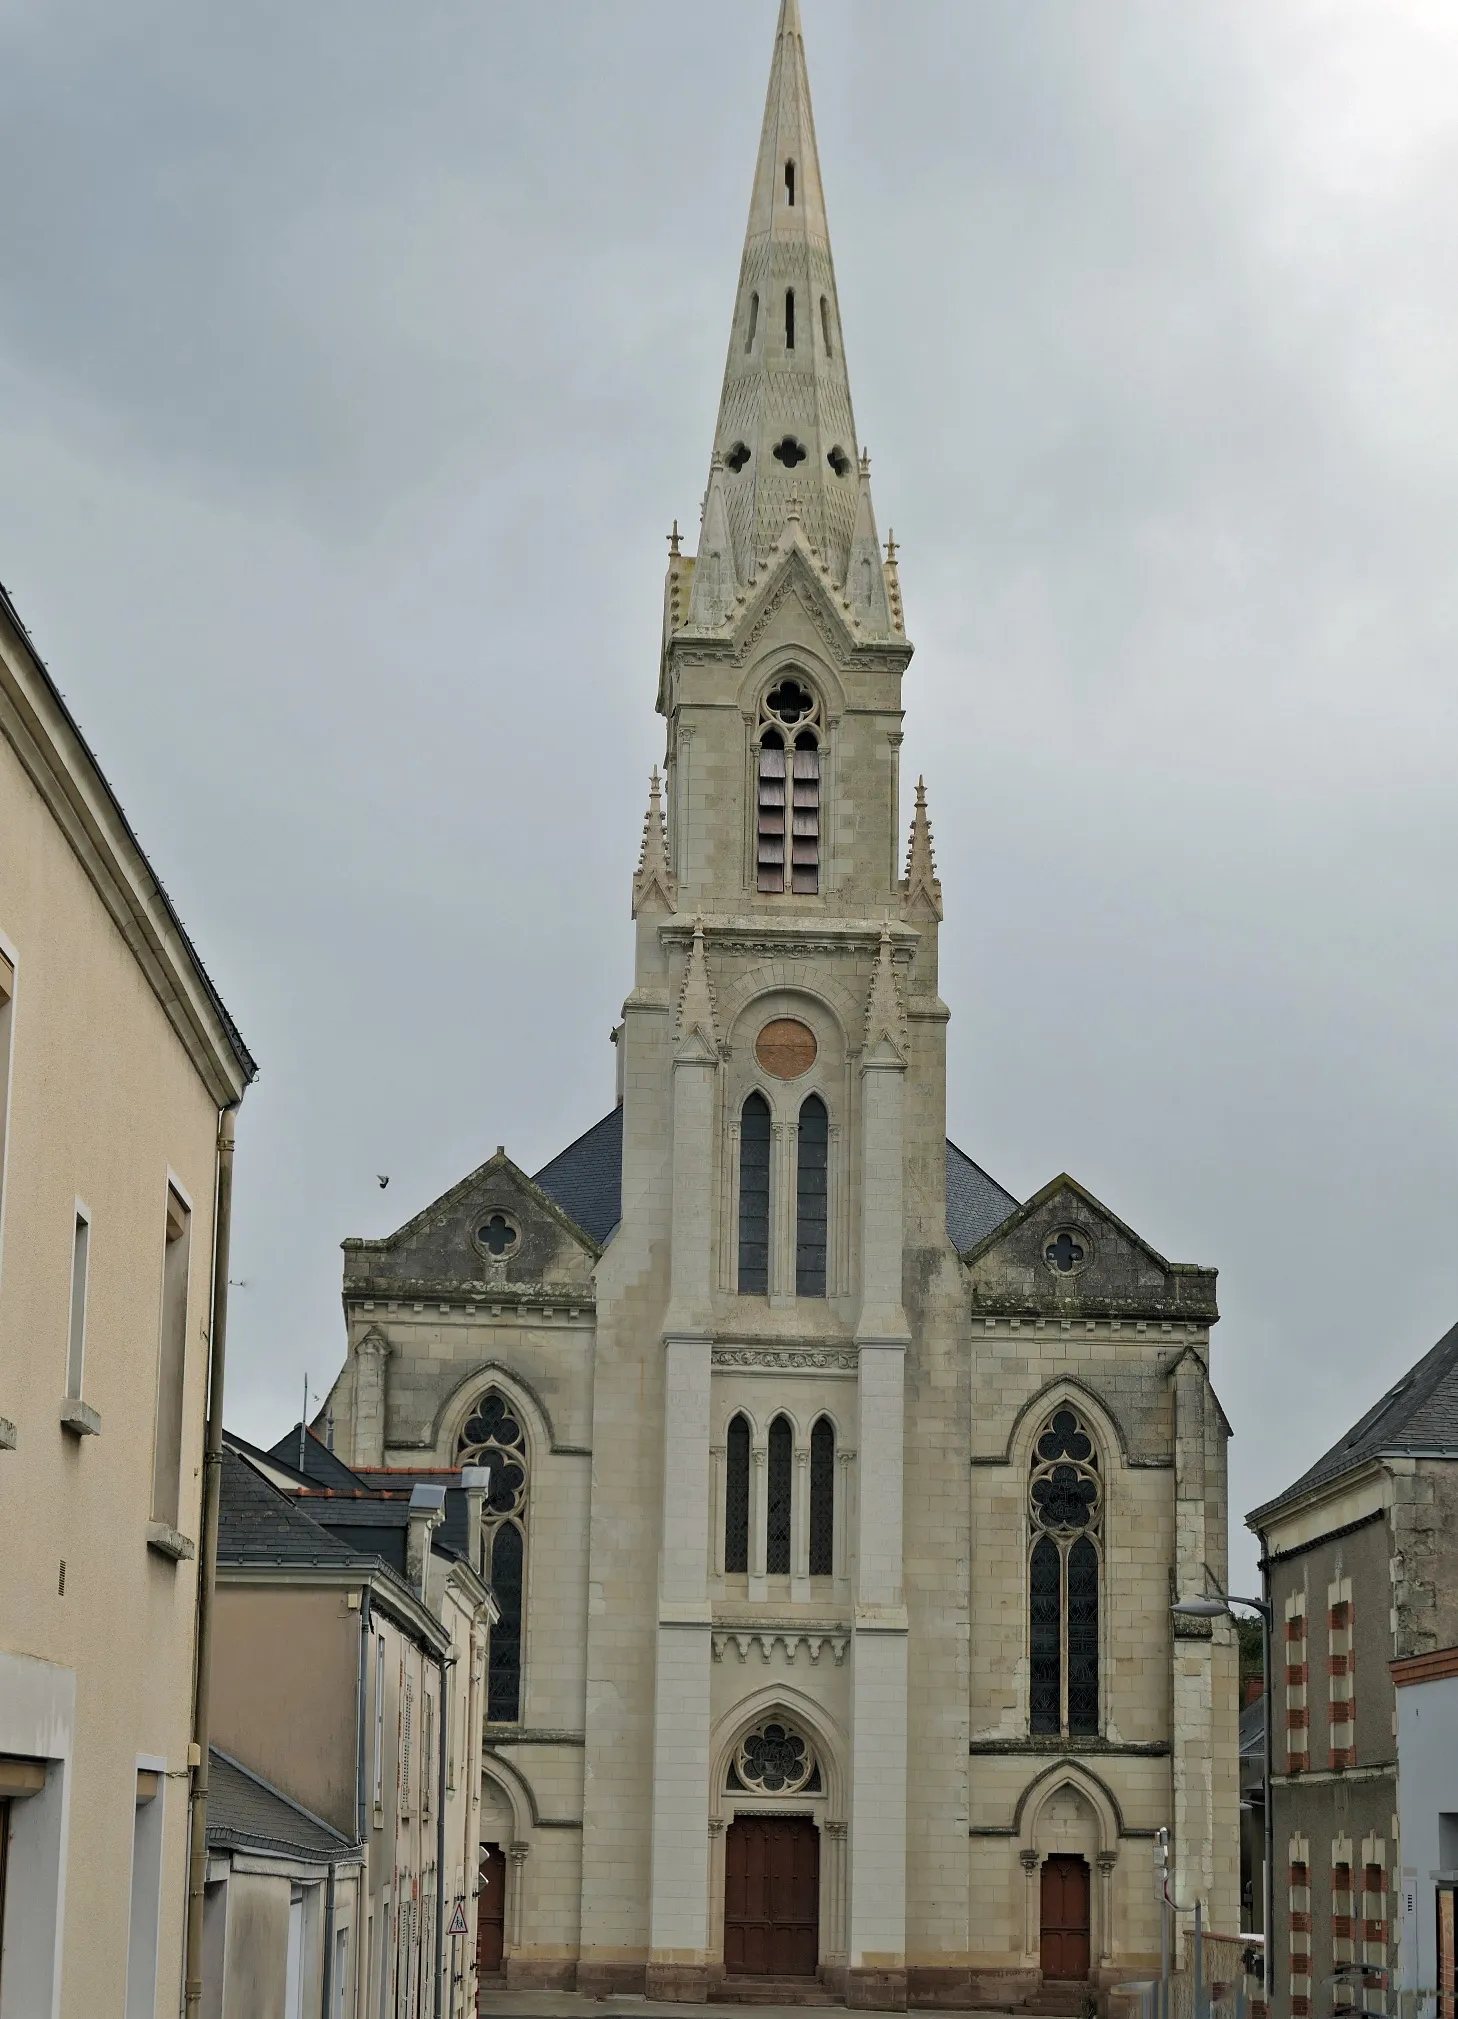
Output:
[{"xmin": 0, "ymin": 0, "xmax": 1458, "ymax": 1577}]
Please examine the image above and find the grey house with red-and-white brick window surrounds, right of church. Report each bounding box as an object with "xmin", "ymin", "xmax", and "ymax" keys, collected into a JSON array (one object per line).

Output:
[{"xmin": 1246, "ymin": 1326, "xmax": 1458, "ymax": 2019}]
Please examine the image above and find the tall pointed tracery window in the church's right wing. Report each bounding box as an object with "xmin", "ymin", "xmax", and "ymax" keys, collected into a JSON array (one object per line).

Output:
[{"xmin": 1028, "ymin": 1403, "xmax": 1103, "ymax": 1738}]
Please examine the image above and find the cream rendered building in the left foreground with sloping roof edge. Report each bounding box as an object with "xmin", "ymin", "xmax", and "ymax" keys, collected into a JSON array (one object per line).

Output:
[{"xmin": 0, "ymin": 573, "xmax": 254, "ymax": 2019}]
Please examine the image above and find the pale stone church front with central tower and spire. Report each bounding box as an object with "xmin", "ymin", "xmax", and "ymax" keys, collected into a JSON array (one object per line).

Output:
[{"xmin": 315, "ymin": 0, "xmax": 1238, "ymax": 2007}]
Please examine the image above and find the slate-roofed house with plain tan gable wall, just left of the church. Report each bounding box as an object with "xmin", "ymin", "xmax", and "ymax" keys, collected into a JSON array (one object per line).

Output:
[{"xmin": 212, "ymin": 1438, "xmax": 495, "ymax": 2019}]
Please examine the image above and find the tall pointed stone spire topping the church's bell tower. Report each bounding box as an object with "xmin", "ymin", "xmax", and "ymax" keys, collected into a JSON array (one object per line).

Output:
[{"xmin": 695, "ymin": 0, "xmax": 864, "ymax": 593}]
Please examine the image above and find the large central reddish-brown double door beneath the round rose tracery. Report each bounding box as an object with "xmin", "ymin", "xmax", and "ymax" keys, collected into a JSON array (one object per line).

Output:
[{"xmin": 723, "ymin": 1815, "xmax": 820, "ymax": 1977}]
